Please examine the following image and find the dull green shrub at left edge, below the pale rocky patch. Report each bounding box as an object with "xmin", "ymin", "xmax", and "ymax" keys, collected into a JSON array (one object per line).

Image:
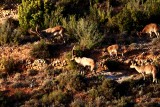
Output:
[{"xmin": 0, "ymin": 18, "xmax": 22, "ymax": 45}]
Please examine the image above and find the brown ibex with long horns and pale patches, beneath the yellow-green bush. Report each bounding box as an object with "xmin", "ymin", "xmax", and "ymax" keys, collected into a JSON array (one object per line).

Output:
[{"xmin": 29, "ymin": 25, "xmax": 66, "ymax": 43}]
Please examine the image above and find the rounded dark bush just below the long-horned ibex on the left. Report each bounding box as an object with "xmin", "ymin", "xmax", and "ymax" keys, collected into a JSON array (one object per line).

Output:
[{"xmin": 30, "ymin": 41, "xmax": 51, "ymax": 59}]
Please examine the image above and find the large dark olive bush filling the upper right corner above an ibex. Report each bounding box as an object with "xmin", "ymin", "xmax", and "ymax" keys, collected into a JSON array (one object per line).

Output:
[{"xmin": 107, "ymin": 0, "xmax": 160, "ymax": 32}]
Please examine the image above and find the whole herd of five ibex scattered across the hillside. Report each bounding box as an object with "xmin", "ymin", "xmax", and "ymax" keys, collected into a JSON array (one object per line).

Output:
[{"xmin": 30, "ymin": 23, "xmax": 160, "ymax": 83}]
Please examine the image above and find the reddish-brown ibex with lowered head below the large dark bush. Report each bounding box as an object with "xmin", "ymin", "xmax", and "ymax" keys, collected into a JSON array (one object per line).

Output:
[{"xmin": 138, "ymin": 23, "xmax": 160, "ymax": 38}]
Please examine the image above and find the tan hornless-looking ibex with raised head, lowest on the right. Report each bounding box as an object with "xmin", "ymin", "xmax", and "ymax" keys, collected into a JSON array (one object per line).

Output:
[{"xmin": 130, "ymin": 62, "xmax": 157, "ymax": 83}]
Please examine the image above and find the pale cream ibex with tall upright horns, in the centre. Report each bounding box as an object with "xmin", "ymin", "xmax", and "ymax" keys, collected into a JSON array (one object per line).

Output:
[{"xmin": 71, "ymin": 46, "xmax": 95, "ymax": 71}]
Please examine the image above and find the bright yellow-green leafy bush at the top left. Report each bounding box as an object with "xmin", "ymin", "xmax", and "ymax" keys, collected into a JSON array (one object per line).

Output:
[{"xmin": 18, "ymin": 0, "xmax": 63, "ymax": 32}]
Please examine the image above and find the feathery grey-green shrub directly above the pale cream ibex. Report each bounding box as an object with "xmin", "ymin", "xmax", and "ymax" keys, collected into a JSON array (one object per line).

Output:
[{"xmin": 76, "ymin": 19, "xmax": 103, "ymax": 49}]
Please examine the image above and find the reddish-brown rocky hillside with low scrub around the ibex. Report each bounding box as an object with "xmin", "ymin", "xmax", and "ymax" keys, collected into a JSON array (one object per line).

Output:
[{"xmin": 0, "ymin": 2, "xmax": 160, "ymax": 107}]
